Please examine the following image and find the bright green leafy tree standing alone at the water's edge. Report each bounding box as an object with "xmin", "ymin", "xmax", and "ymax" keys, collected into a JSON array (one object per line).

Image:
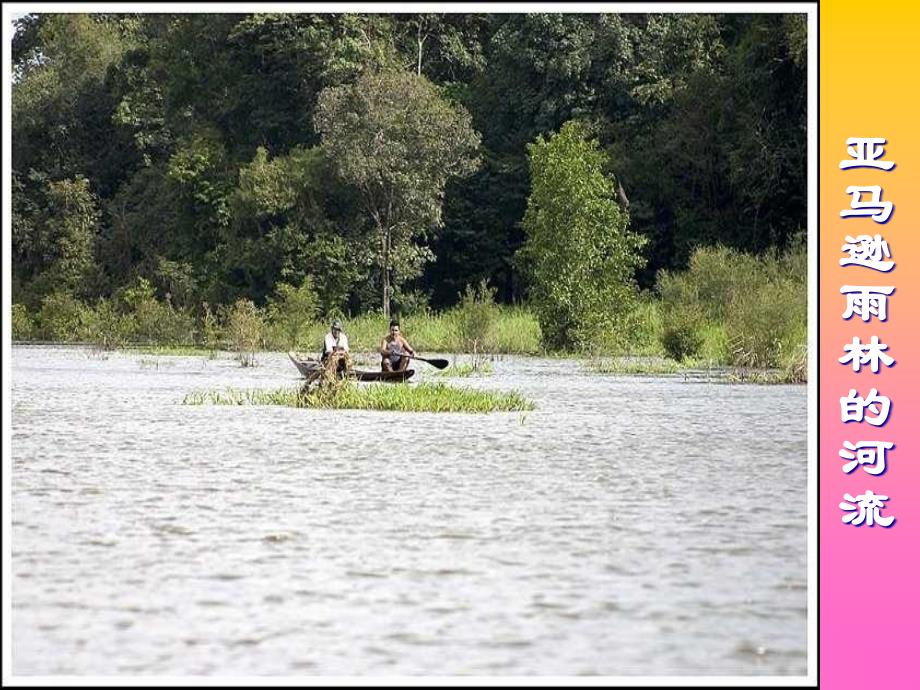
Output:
[{"xmin": 520, "ymin": 121, "xmax": 644, "ymax": 348}]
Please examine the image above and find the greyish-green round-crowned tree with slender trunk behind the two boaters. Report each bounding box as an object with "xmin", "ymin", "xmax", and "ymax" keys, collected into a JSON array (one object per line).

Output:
[{"xmin": 315, "ymin": 72, "xmax": 479, "ymax": 316}]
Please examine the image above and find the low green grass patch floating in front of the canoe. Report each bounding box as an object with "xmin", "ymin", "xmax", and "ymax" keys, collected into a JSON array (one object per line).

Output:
[{"xmin": 182, "ymin": 381, "xmax": 535, "ymax": 412}]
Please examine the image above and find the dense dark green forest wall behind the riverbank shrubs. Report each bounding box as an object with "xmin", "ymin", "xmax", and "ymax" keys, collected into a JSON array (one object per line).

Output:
[{"xmin": 12, "ymin": 14, "xmax": 806, "ymax": 314}]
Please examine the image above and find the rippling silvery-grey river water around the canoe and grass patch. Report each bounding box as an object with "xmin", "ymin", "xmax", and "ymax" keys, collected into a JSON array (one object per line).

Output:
[{"xmin": 11, "ymin": 346, "xmax": 807, "ymax": 676}]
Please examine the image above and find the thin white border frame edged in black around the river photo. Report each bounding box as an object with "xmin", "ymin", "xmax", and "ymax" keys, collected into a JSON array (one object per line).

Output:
[{"xmin": 0, "ymin": 2, "xmax": 819, "ymax": 687}]
